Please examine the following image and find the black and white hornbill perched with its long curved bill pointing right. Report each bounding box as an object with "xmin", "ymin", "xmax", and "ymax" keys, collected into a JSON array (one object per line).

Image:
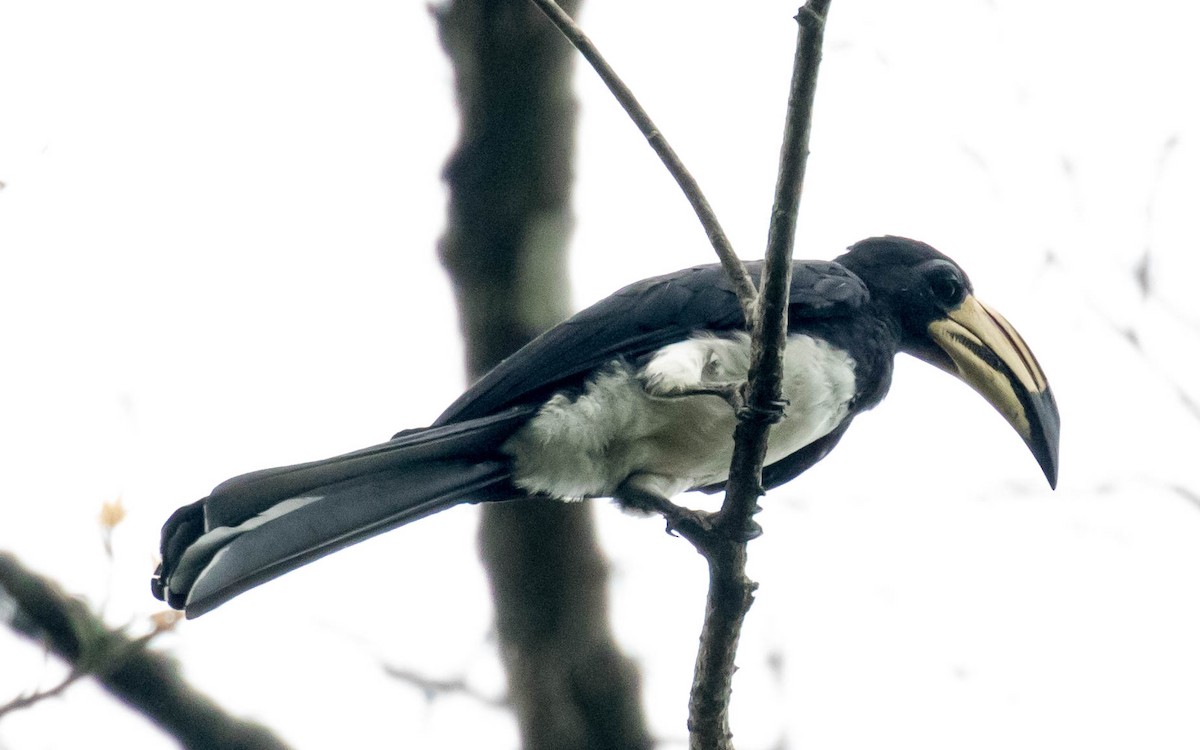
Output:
[{"xmin": 152, "ymin": 236, "xmax": 1058, "ymax": 617}]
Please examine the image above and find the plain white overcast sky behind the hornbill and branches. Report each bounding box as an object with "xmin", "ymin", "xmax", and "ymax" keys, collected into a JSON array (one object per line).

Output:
[{"xmin": 0, "ymin": 0, "xmax": 1200, "ymax": 750}]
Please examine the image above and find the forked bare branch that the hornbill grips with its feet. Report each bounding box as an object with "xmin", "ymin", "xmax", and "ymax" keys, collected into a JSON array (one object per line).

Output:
[{"xmin": 532, "ymin": 0, "xmax": 830, "ymax": 750}]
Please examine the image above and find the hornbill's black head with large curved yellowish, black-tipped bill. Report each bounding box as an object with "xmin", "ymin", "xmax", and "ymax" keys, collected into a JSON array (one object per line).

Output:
[{"xmin": 838, "ymin": 236, "xmax": 1058, "ymax": 487}]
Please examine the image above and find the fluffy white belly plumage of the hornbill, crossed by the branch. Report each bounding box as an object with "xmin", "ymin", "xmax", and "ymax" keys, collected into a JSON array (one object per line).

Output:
[{"xmin": 502, "ymin": 332, "xmax": 854, "ymax": 498}]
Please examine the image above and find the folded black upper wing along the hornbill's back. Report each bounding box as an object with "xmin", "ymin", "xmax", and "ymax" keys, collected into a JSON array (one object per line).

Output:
[{"xmin": 434, "ymin": 260, "xmax": 869, "ymax": 425}]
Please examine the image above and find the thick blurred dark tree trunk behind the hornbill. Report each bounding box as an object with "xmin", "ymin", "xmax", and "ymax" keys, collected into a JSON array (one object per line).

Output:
[{"xmin": 434, "ymin": 0, "xmax": 652, "ymax": 750}]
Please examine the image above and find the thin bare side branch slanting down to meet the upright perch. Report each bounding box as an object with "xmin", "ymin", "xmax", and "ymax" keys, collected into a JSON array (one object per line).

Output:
[{"xmin": 532, "ymin": 0, "xmax": 758, "ymax": 322}]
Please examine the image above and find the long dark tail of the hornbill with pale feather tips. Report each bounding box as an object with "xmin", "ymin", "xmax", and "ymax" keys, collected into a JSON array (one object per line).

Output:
[{"xmin": 151, "ymin": 407, "xmax": 530, "ymax": 618}]
